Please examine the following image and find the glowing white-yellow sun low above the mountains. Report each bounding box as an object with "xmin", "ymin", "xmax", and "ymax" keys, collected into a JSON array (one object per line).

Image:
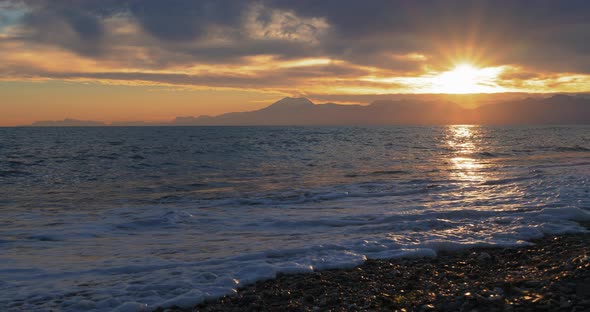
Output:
[{"xmin": 432, "ymin": 63, "xmax": 503, "ymax": 94}]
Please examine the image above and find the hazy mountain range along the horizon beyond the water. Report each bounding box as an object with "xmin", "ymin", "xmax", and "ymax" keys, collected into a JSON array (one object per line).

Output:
[{"xmin": 27, "ymin": 95, "xmax": 590, "ymax": 126}]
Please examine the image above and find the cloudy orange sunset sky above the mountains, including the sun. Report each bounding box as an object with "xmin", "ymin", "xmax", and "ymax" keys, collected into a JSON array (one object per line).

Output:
[{"xmin": 0, "ymin": 0, "xmax": 590, "ymax": 126}]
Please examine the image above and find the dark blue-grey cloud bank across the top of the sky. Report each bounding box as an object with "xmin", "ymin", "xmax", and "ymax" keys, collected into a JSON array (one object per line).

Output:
[{"xmin": 4, "ymin": 0, "xmax": 590, "ymax": 73}]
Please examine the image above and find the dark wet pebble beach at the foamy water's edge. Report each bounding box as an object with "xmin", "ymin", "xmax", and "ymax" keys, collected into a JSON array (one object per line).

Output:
[{"xmin": 162, "ymin": 223, "xmax": 590, "ymax": 311}]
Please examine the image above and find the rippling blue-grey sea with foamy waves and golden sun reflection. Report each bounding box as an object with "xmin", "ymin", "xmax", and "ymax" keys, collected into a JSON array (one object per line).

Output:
[{"xmin": 0, "ymin": 125, "xmax": 590, "ymax": 311}]
